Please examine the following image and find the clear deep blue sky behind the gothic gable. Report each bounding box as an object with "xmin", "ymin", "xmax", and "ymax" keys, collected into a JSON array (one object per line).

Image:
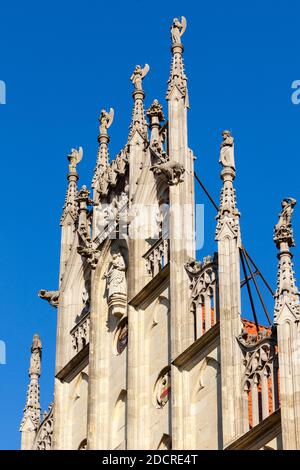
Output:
[{"xmin": 0, "ymin": 0, "xmax": 300, "ymax": 449}]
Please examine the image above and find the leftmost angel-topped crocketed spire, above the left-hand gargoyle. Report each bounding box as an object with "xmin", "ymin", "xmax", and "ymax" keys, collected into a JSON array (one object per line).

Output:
[{"xmin": 60, "ymin": 147, "xmax": 83, "ymax": 225}]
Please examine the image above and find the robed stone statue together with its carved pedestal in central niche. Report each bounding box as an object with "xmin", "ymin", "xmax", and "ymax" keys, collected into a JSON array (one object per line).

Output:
[{"xmin": 103, "ymin": 251, "xmax": 127, "ymax": 317}]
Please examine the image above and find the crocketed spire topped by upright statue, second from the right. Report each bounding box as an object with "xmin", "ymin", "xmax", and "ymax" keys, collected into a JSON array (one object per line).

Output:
[{"xmin": 216, "ymin": 131, "xmax": 240, "ymax": 240}]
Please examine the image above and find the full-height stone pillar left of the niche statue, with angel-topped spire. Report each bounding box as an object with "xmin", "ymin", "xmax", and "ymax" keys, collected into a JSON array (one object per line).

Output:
[{"xmin": 87, "ymin": 108, "xmax": 114, "ymax": 450}]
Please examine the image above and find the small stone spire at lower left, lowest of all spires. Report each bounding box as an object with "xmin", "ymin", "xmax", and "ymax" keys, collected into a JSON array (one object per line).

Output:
[{"xmin": 20, "ymin": 334, "xmax": 42, "ymax": 450}]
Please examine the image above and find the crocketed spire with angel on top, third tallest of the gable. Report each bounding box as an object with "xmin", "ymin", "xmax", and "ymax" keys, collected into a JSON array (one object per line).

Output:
[{"xmin": 92, "ymin": 108, "xmax": 114, "ymax": 193}]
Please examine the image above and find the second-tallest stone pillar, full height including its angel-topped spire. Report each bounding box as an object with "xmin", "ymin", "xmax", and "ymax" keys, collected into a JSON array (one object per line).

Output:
[{"xmin": 127, "ymin": 64, "xmax": 150, "ymax": 449}]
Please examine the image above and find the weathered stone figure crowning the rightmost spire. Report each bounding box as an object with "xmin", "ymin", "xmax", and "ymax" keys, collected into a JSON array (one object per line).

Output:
[{"xmin": 274, "ymin": 197, "xmax": 297, "ymax": 248}]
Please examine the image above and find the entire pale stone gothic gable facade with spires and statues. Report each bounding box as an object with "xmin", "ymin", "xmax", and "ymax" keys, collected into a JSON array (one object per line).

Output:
[{"xmin": 20, "ymin": 17, "xmax": 300, "ymax": 450}]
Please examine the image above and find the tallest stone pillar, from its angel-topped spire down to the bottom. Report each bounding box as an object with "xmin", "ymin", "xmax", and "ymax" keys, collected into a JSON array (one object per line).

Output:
[{"xmin": 165, "ymin": 19, "xmax": 195, "ymax": 449}]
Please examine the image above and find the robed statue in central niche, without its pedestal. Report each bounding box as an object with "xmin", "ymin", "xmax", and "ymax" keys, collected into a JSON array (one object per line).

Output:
[{"xmin": 103, "ymin": 252, "xmax": 127, "ymax": 299}]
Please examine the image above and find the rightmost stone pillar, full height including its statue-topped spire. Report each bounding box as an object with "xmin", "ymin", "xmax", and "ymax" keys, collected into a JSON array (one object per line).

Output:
[{"xmin": 274, "ymin": 198, "xmax": 300, "ymax": 450}]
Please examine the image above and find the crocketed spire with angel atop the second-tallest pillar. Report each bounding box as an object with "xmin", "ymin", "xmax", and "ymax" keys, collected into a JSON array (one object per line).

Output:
[{"xmin": 128, "ymin": 64, "xmax": 150, "ymax": 141}]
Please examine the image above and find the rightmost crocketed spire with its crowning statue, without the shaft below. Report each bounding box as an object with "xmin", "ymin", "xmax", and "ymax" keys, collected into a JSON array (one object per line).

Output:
[{"xmin": 274, "ymin": 197, "xmax": 300, "ymax": 324}]
